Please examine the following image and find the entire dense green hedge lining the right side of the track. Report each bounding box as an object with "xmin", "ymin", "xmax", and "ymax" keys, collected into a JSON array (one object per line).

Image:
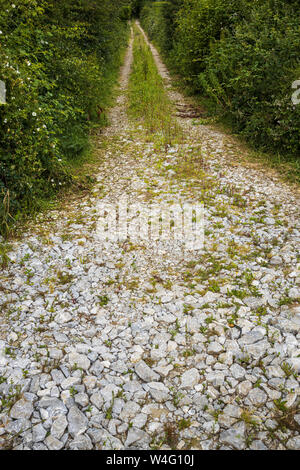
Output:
[{"xmin": 141, "ymin": 0, "xmax": 300, "ymax": 176}]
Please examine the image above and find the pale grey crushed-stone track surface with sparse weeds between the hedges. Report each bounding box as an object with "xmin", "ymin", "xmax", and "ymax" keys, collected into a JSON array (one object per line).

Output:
[{"xmin": 0, "ymin": 23, "xmax": 300, "ymax": 450}]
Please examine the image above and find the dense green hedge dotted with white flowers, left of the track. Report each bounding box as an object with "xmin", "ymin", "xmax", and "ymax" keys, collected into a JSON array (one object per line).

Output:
[{"xmin": 0, "ymin": 0, "xmax": 130, "ymax": 232}]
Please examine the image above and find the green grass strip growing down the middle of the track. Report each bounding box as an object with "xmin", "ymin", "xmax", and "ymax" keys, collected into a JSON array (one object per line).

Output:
[{"xmin": 128, "ymin": 25, "xmax": 180, "ymax": 146}]
